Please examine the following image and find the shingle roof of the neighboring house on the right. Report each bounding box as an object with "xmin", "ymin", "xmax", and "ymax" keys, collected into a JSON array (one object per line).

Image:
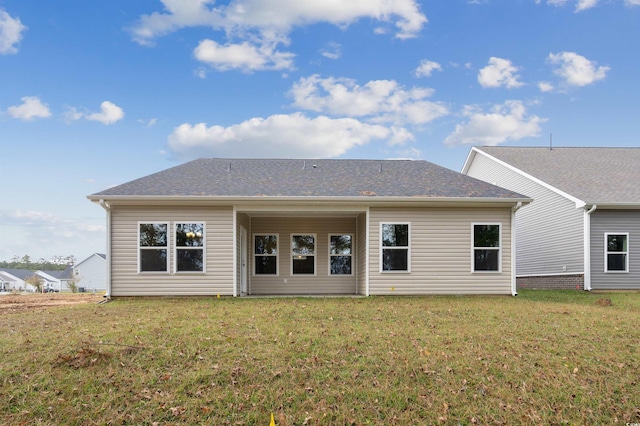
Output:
[{"xmin": 462, "ymin": 147, "xmax": 640, "ymax": 207}]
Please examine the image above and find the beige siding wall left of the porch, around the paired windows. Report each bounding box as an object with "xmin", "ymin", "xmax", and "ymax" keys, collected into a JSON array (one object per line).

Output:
[{"xmin": 111, "ymin": 206, "xmax": 234, "ymax": 296}]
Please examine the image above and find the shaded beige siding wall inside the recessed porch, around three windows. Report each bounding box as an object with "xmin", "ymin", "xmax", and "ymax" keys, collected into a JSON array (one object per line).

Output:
[{"xmin": 249, "ymin": 217, "xmax": 359, "ymax": 295}]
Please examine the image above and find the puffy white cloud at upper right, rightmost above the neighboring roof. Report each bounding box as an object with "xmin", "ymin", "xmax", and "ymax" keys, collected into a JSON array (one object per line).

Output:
[{"xmin": 548, "ymin": 52, "xmax": 611, "ymax": 87}]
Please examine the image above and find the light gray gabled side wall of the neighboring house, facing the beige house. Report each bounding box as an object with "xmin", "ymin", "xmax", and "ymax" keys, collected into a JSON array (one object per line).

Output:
[{"xmin": 467, "ymin": 153, "xmax": 584, "ymax": 280}]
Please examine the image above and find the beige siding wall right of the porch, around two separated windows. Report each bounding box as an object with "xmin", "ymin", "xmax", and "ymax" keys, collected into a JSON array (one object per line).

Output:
[{"xmin": 369, "ymin": 208, "xmax": 511, "ymax": 295}]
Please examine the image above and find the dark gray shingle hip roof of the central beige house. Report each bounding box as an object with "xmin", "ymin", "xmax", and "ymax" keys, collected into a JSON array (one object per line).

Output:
[{"xmin": 89, "ymin": 158, "xmax": 526, "ymax": 200}]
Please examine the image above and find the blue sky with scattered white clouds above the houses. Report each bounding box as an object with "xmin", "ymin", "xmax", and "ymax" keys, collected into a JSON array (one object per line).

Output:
[{"xmin": 0, "ymin": 0, "xmax": 640, "ymax": 260}]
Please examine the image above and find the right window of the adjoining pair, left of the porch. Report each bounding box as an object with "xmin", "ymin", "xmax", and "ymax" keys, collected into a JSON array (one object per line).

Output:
[{"xmin": 175, "ymin": 223, "xmax": 205, "ymax": 272}]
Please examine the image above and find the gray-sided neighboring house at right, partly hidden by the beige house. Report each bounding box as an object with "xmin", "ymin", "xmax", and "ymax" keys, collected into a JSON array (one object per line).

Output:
[{"xmin": 462, "ymin": 147, "xmax": 640, "ymax": 290}]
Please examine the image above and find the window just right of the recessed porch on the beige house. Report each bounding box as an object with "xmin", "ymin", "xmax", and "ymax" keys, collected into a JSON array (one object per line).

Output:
[{"xmin": 380, "ymin": 223, "xmax": 411, "ymax": 272}]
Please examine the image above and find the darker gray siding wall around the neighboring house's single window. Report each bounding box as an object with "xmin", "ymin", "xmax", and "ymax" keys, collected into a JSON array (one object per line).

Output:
[{"xmin": 591, "ymin": 210, "xmax": 640, "ymax": 290}]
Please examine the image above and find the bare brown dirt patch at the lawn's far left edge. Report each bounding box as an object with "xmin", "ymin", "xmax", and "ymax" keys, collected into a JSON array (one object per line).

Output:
[{"xmin": 0, "ymin": 293, "xmax": 103, "ymax": 315}]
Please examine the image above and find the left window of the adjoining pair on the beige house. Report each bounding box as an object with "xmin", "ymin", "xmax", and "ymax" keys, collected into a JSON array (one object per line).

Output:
[{"xmin": 138, "ymin": 223, "xmax": 169, "ymax": 272}]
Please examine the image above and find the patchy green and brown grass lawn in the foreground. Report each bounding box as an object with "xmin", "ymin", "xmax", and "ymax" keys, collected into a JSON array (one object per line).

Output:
[{"xmin": 0, "ymin": 290, "xmax": 640, "ymax": 426}]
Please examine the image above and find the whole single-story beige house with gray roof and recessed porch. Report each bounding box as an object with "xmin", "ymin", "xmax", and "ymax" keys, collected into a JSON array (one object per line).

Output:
[{"xmin": 88, "ymin": 159, "xmax": 531, "ymax": 297}]
